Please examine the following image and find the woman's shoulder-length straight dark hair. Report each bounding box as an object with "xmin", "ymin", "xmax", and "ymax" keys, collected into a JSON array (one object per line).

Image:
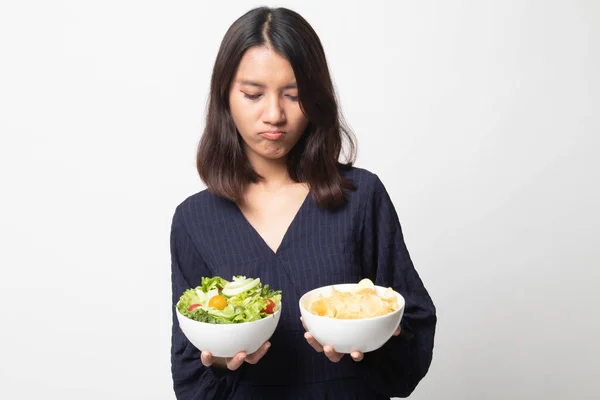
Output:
[{"xmin": 196, "ymin": 7, "xmax": 356, "ymax": 210}]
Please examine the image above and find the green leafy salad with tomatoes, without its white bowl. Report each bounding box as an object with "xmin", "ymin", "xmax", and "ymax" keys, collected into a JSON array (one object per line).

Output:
[{"xmin": 177, "ymin": 276, "xmax": 281, "ymax": 324}]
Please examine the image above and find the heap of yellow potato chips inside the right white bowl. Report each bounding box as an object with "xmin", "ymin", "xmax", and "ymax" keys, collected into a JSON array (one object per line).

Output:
[{"xmin": 308, "ymin": 279, "xmax": 399, "ymax": 319}]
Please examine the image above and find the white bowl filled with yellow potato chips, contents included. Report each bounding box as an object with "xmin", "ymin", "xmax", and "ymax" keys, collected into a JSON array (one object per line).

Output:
[{"xmin": 299, "ymin": 279, "xmax": 404, "ymax": 353}]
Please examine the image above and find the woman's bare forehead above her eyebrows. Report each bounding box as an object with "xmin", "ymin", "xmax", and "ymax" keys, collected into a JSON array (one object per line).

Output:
[{"xmin": 235, "ymin": 47, "xmax": 295, "ymax": 86}]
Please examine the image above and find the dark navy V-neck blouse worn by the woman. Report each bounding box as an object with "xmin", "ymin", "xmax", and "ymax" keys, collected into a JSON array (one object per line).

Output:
[{"xmin": 171, "ymin": 168, "xmax": 436, "ymax": 400}]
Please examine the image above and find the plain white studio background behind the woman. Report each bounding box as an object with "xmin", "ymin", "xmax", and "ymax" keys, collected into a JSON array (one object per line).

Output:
[{"xmin": 0, "ymin": 0, "xmax": 600, "ymax": 399}]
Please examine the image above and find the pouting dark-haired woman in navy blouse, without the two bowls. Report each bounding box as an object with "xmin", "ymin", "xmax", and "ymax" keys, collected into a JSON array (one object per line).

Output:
[{"xmin": 171, "ymin": 7, "xmax": 436, "ymax": 400}]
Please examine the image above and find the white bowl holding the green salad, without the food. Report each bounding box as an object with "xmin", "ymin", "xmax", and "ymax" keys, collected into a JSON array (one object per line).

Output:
[{"xmin": 175, "ymin": 304, "xmax": 281, "ymax": 357}]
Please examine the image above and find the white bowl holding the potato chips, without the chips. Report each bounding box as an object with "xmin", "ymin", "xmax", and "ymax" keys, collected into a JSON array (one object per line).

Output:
[{"xmin": 300, "ymin": 283, "xmax": 404, "ymax": 353}]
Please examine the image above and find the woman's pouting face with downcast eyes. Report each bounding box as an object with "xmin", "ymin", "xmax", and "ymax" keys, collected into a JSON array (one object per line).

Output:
[{"xmin": 229, "ymin": 47, "xmax": 308, "ymax": 161}]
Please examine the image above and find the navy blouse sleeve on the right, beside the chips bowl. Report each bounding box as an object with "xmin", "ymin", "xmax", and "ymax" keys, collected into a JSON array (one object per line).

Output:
[{"xmin": 358, "ymin": 176, "xmax": 437, "ymax": 397}]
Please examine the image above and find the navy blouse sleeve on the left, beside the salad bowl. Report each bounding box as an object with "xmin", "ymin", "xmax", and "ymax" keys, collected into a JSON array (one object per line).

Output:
[{"xmin": 171, "ymin": 209, "xmax": 235, "ymax": 400}]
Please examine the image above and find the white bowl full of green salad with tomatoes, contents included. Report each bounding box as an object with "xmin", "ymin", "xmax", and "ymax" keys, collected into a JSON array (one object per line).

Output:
[{"xmin": 175, "ymin": 276, "xmax": 281, "ymax": 357}]
